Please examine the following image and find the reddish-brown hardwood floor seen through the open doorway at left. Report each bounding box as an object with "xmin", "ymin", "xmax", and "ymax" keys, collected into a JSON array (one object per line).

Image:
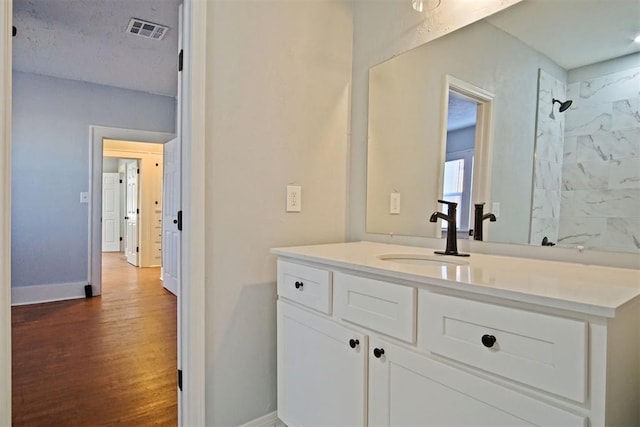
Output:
[{"xmin": 12, "ymin": 253, "xmax": 178, "ymax": 426}]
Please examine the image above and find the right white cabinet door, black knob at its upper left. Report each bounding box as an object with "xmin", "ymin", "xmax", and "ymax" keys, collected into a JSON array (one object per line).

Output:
[{"xmin": 369, "ymin": 339, "xmax": 586, "ymax": 427}]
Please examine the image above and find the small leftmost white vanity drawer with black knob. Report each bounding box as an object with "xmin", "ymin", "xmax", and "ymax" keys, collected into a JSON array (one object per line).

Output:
[{"xmin": 278, "ymin": 260, "xmax": 331, "ymax": 314}]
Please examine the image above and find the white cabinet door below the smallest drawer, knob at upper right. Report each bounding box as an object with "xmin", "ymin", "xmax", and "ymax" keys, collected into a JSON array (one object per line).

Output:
[{"xmin": 278, "ymin": 301, "xmax": 367, "ymax": 426}]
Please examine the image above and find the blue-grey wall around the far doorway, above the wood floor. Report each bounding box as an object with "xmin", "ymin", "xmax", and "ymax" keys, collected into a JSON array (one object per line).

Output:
[{"xmin": 11, "ymin": 72, "xmax": 175, "ymax": 287}]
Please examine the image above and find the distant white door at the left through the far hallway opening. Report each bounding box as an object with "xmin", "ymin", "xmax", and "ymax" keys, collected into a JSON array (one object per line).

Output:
[{"xmin": 102, "ymin": 172, "xmax": 120, "ymax": 252}]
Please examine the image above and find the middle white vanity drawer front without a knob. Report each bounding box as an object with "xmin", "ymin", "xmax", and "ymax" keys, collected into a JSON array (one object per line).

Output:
[{"xmin": 333, "ymin": 273, "xmax": 416, "ymax": 343}]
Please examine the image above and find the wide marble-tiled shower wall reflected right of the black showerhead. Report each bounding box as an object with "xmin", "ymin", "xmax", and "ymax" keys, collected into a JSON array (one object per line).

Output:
[{"xmin": 558, "ymin": 67, "xmax": 640, "ymax": 252}]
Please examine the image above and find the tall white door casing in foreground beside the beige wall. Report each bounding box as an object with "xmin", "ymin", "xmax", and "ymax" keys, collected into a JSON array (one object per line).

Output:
[{"xmin": 178, "ymin": 0, "xmax": 208, "ymax": 426}]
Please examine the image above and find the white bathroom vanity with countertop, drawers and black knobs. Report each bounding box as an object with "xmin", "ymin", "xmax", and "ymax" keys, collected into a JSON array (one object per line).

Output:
[{"xmin": 272, "ymin": 242, "xmax": 640, "ymax": 426}]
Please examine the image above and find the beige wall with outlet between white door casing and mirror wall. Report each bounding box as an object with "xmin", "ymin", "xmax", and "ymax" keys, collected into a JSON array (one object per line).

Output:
[{"xmin": 204, "ymin": 1, "xmax": 352, "ymax": 425}]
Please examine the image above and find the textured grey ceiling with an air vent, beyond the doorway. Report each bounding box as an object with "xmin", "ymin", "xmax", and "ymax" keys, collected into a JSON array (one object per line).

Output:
[{"xmin": 13, "ymin": 0, "xmax": 180, "ymax": 96}]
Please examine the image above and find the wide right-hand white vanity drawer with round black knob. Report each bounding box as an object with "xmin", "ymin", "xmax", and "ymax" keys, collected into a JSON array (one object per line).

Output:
[{"xmin": 418, "ymin": 290, "xmax": 588, "ymax": 402}]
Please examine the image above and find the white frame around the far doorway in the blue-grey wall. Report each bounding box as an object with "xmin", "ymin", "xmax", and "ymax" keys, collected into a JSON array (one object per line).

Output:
[{"xmin": 88, "ymin": 126, "xmax": 176, "ymax": 295}]
